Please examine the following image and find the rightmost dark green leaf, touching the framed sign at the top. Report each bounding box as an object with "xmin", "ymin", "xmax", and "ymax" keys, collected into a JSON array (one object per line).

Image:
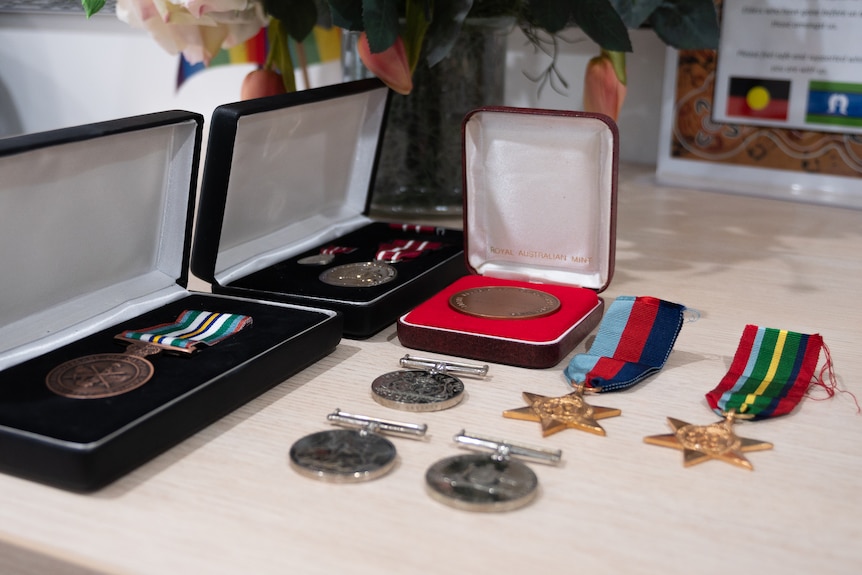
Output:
[{"xmin": 650, "ymin": 0, "xmax": 719, "ymax": 50}]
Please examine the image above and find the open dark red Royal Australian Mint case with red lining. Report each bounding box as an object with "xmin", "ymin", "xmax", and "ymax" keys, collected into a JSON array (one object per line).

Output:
[{"xmin": 398, "ymin": 107, "xmax": 618, "ymax": 368}]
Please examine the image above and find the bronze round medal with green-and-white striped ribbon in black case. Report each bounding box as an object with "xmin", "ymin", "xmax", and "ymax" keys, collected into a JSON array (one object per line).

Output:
[{"xmin": 45, "ymin": 310, "xmax": 252, "ymax": 399}]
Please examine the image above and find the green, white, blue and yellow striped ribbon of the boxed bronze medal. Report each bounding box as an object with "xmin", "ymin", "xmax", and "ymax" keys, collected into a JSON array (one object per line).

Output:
[{"xmin": 119, "ymin": 310, "xmax": 251, "ymax": 350}]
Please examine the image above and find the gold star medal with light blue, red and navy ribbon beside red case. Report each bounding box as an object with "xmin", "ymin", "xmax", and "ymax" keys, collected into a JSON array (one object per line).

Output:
[{"xmin": 503, "ymin": 296, "xmax": 685, "ymax": 437}]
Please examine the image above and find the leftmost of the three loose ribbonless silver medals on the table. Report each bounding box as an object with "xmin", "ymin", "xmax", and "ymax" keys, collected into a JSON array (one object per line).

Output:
[{"xmin": 289, "ymin": 409, "xmax": 427, "ymax": 483}]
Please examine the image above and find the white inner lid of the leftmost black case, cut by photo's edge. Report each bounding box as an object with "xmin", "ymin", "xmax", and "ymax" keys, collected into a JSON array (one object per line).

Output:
[{"xmin": 0, "ymin": 121, "xmax": 197, "ymax": 369}]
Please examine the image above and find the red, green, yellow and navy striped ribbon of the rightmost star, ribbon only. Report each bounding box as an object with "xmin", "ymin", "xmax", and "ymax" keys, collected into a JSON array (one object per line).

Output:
[{"xmin": 706, "ymin": 325, "xmax": 823, "ymax": 420}]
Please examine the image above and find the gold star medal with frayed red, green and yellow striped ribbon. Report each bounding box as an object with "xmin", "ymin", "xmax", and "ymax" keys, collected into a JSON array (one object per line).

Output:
[{"xmin": 644, "ymin": 325, "xmax": 831, "ymax": 469}]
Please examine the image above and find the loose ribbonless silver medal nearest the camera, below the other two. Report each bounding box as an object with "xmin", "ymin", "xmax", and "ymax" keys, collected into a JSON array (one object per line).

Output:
[{"xmin": 425, "ymin": 431, "xmax": 562, "ymax": 511}]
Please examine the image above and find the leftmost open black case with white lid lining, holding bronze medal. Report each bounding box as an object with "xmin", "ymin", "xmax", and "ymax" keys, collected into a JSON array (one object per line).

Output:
[{"xmin": 0, "ymin": 111, "xmax": 341, "ymax": 491}]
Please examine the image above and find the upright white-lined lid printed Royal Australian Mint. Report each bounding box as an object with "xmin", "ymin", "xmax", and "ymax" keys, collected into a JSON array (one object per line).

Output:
[{"xmin": 464, "ymin": 111, "xmax": 615, "ymax": 289}]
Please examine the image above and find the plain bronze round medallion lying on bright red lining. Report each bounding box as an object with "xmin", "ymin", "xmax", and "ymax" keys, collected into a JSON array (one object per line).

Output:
[{"xmin": 449, "ymin": 286, "xmax": 560, "ymax": 319}]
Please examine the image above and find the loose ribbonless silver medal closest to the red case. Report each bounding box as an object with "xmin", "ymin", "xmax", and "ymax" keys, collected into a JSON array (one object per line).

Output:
[{"xmin": 371, "ymin": 355, "xmax": 488, "ymax": 411}]
